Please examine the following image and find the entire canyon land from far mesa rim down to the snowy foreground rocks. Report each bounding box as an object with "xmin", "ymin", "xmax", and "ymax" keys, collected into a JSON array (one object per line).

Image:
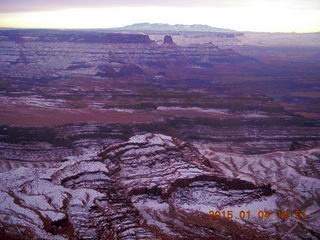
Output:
[{"xmin": 0, "ymin": 30, "xmax": 320, "ymax": 240}]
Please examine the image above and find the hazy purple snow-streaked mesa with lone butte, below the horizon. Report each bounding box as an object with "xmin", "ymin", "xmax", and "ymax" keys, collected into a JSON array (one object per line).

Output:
[{"xmin": 0, "ymin": 30, "xmax": 257, "ymax": 81}]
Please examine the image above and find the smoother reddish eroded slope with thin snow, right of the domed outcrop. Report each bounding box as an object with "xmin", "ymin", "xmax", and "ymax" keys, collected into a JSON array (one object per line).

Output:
[{"xmin": 198, "ymin": 144, "xmax": 320, "ymax": 239}]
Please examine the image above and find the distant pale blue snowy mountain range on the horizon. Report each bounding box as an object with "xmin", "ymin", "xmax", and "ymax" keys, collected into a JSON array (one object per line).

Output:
[{"xmin": 120, "ymin": 23, "xmax": 235, "ymax": 32}]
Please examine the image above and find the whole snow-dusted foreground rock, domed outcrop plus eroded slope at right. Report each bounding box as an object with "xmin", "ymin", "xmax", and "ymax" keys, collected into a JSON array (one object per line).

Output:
[{"xmin": 0, "ymin": 134, "xmax": 319, "ymax": 239}]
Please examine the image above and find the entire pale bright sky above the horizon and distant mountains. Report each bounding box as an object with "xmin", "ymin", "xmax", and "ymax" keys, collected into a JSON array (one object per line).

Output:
[{"xmin": 0, "ymin": 0, "xmax": 320, "ymax": 32}]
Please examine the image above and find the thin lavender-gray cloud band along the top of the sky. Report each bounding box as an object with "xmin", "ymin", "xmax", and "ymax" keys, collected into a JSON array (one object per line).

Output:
[{"xmin": 0, "ymin": 0, "xmax": 320, "ymax": 13}]
